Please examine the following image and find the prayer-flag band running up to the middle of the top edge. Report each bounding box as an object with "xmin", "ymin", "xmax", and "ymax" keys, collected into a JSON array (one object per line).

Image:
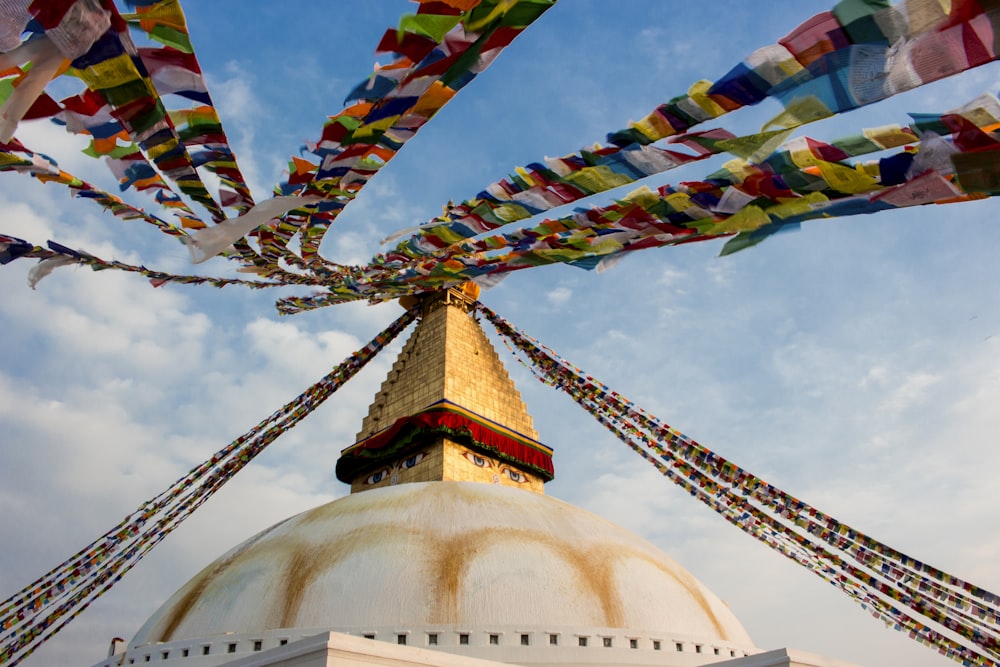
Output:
[{"xmin": 262, "ymin": 0, "xmax": 554, "ymax": 274}]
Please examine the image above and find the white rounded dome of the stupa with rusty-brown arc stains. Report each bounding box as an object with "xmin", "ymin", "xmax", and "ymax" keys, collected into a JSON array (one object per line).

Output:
[{"xmin": 117, "ymin": 482, "xmax": 754, "ymax": 665}]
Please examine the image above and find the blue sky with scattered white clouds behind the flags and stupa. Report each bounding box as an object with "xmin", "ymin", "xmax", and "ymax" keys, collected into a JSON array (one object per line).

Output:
[{"xmin": 0, "ymin": 0, "xmax": 1000, "ymax": 667}]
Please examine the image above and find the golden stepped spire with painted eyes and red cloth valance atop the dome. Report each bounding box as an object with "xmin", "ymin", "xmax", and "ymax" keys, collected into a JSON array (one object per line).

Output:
[{"xmin": 337, "ymin": 283, "xmax": 552, "ymax": 492}]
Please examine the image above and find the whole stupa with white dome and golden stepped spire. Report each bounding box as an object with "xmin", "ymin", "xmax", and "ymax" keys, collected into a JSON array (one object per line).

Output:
[{"xmin": 95, "ymin": 285, "xmax": 860, "ymax": 667}]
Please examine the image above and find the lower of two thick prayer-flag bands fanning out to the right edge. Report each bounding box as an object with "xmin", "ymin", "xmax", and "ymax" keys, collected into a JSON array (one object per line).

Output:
[{"xmin": 277, "ymin": 97, "xmax": 1000, "ymax": 313}]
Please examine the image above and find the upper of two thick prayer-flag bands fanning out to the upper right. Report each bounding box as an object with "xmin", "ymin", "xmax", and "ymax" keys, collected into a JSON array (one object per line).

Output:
[{"xmin": 390, "ymin": 0, "xmax": 1000, "ymax": 260}]
